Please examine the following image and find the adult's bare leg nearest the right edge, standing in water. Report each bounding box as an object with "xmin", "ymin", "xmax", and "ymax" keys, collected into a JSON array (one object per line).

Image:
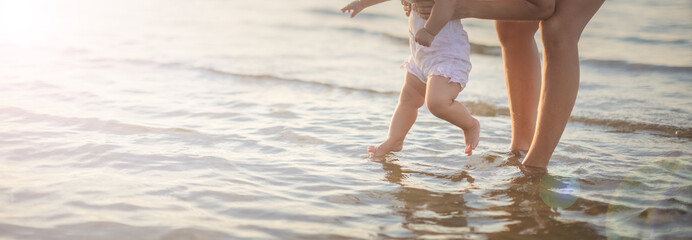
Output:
[{"xmin": 523, "ymin": 0, "xmax": 604, "ymax": 168}]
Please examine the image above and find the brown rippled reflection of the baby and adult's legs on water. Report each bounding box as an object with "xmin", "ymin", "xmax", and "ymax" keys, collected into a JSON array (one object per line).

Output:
[{"xmin": 373, "ymin": 155, "xmax": 606, "ymax": 239}]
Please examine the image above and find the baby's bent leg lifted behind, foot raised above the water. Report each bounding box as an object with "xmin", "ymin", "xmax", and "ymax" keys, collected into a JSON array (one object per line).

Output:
[{"xmin": 425, "ymin": 75, "xmax": 481, "ymax": 156}]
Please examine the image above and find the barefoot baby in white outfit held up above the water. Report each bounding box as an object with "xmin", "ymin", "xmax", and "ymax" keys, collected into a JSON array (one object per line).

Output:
[{"xmin": 341, "ymin": 0, "xmax": 480, "ymax": 157}]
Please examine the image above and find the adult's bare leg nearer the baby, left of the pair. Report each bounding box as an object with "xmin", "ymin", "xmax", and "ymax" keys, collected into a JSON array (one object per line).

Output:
[{"xmin": 495, "ymin": 21, "xmax": 541, "ymax": 152}]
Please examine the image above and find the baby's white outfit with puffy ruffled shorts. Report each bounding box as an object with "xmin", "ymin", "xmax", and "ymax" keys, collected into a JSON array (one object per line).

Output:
[{"xmin": 402, "ymin": 12, "xmax": 471, "ymax": 88}]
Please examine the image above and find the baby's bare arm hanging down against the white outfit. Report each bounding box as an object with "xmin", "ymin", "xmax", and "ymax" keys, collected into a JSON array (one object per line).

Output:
[{"xmin": 415, "ymin": 0, "xmax": 457, "ymax": 47}]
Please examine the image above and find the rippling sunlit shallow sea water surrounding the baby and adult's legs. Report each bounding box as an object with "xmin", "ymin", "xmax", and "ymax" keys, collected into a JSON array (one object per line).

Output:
[{"xmin": 0, "ymin": 0, "xmax": 692, "ymax": 239}]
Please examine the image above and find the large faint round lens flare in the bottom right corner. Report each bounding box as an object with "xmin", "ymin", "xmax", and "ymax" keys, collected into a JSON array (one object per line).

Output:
[{"xmin": 606, "ymin": 158, "xmax": 692, "ymax": 239}]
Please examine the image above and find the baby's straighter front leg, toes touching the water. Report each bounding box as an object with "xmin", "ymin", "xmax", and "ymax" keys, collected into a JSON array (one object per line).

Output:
[{"xmin": 368, "ymin": 72, "xmax": 425, "ymax": 157}]
